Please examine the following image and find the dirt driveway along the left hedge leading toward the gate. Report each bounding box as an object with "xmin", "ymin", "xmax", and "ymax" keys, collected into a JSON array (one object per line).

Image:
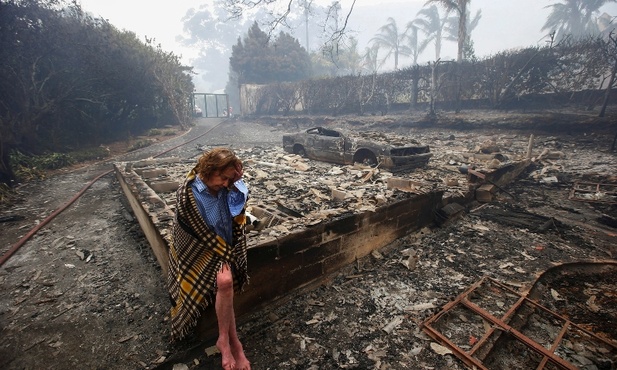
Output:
[{"xmin": 0, "ymin": 120, "xmax": 229, "ymax": 369}]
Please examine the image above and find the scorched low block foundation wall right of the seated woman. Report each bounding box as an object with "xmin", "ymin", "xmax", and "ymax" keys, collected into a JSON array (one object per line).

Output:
[{"xmin": 237, "ymin": 192, "xmax": 442, "ymax": 310}]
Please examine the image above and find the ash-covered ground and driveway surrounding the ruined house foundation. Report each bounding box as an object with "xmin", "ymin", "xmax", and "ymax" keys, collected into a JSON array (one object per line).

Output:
[{"xmin": 0, "ymin": 113, "xmax": 617, "ymax": 369}]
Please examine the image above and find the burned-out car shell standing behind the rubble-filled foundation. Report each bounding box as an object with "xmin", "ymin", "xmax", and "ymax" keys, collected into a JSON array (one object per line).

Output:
[{"xmin": 283, "ymin": 127, "xmax": 432, "ymax": 172}]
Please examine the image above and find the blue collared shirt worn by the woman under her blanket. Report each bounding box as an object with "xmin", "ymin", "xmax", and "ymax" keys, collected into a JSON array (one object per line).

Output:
[{"xmin": 191, "ymin": 176, "xmax": 248, "ymax": 245}]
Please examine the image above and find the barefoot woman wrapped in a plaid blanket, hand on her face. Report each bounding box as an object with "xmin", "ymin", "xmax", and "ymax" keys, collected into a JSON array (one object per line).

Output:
[{"xmin": 168, "ymin": 148, "xmax": 250, "ymax": 370}]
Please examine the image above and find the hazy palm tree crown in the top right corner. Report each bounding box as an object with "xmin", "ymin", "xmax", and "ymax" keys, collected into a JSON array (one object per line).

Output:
[{"xmin": 542, "ymin": 0, "xmax": 617, "ymax": 41}]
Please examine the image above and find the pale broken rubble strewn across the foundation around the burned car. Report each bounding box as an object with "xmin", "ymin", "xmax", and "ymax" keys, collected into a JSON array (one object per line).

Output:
[{"xmin": 150, "ymin": 130, "xmax": 611, "ymax": 243}]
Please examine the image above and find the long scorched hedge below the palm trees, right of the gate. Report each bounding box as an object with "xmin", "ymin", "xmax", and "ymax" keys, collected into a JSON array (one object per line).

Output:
[{"xmin": 240, "ymin": 39, "xmax": 617, "ymax": 115}]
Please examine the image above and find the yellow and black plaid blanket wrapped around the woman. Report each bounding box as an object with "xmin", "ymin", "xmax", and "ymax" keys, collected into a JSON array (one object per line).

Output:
[{"xmin": 167, "ymin": 170, "xmax": 248, "ymax": 340}]
